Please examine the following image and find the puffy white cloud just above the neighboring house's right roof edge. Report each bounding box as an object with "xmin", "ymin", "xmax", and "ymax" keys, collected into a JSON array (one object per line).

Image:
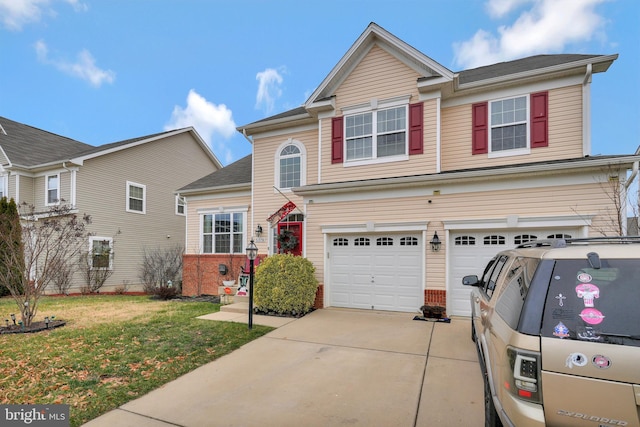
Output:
[{"xmin": 164, "ymin": 89, "xmax": 236, "ymax": 163}]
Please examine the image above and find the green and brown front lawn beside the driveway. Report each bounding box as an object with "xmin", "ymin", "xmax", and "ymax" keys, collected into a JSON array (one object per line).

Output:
[{"xmin": 0, "ymin": 296, "xmax": 272, "ymax": 426}]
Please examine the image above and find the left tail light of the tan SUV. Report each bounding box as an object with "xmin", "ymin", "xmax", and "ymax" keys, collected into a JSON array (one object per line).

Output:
[{"xmin": 504, "ymin": 347, "xmax": 542, "ymax": 403}]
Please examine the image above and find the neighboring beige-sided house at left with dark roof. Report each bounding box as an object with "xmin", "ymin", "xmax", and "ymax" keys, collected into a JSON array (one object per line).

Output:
[{"xmin": 0, "ymin": 117, "xmax": 222, "ymax": 293}]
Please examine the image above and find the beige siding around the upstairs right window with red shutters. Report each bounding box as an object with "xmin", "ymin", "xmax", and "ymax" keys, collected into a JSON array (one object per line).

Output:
[{"xmin": 442, "ymin": 85, "xmax": 583, "ymax": 171}]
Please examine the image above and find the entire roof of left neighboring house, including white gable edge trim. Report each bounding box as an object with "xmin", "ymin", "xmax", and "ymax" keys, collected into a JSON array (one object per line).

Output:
[{"xmin": 0, "ymin": 117, "xmax": 222, "ymax": 169}]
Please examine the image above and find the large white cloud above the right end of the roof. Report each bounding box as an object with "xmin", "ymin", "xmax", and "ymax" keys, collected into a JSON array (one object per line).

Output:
[{"xmin": 453, "ymin": 0, "xmax": 607, "ymax": 68}]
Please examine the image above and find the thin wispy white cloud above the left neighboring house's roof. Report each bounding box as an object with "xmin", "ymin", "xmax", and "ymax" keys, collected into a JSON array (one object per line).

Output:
[{"xmin": 35, "ymin": 40, "xmax": 116, "ymax": 87}]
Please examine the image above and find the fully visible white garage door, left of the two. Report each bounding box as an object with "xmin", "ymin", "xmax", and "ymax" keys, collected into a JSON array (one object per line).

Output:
[{"xmin": 325, "ymin": 234, "xmax": 424, "ymax": 312}]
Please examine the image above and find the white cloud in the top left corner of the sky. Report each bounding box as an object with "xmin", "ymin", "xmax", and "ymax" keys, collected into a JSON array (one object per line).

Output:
[{"xmin": 0, "ymin": 0, "xmax": 89, "ymax": 31}]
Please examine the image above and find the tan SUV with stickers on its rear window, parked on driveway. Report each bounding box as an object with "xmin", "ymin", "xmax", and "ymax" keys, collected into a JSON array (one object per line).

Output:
[{"xmin": 463, "ymin": 237, "xmax": 640, "ymax": 427}]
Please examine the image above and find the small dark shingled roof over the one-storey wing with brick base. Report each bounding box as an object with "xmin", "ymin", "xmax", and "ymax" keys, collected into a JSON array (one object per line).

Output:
[{"xmin": 176, "ymin": 154, "xmax": 252, "ymax": 195}]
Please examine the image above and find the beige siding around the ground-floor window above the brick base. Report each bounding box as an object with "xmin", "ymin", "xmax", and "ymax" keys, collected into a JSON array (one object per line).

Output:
[{"xmin": 185, "ymin": 196, "xmax": 251, "ymax": 254}]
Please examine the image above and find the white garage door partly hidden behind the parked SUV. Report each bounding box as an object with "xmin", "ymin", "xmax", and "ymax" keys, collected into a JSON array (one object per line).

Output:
[{"xmin": 447, "ymin": 230, "xmax": 577, "ymax": 316}]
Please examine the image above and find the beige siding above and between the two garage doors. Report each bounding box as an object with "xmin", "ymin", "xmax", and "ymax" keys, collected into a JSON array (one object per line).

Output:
[{"xmin": 306, "ymin": 182, "xmax": 615, "ymax": 289}]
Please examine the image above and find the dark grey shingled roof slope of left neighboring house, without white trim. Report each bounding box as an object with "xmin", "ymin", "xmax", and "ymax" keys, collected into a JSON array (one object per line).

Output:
[{"xmin": 0, "ymin": 117, "xmax": 94, "ymax": 168}]
